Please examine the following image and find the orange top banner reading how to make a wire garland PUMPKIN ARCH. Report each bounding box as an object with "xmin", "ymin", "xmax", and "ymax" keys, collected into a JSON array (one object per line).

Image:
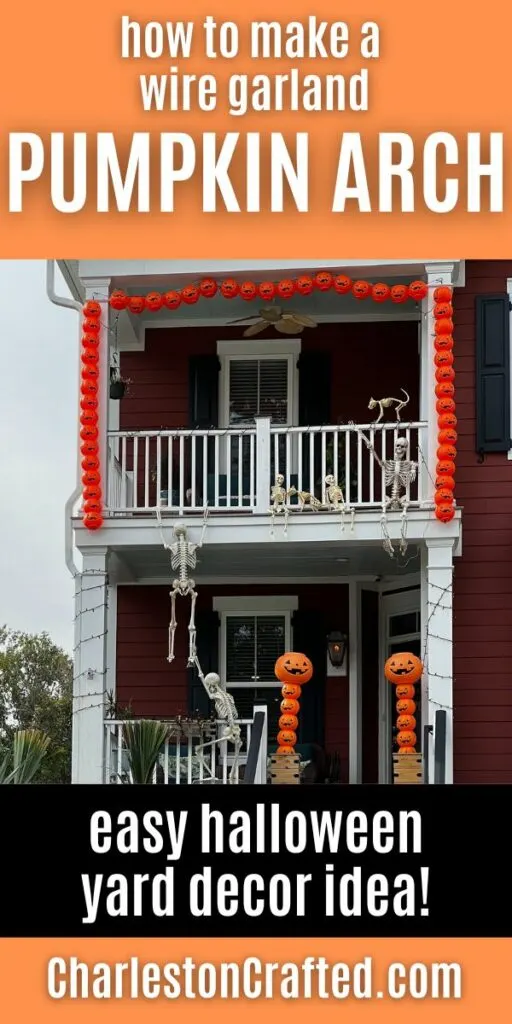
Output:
[{"xmin": 0, "ymin": 0, "xmax": 512, "ymax": 259}]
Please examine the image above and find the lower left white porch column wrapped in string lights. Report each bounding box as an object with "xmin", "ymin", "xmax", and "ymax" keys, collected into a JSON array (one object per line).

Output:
[{"xmin": 72, "ymin": 547, "xmax": 108, "ymax": 783}]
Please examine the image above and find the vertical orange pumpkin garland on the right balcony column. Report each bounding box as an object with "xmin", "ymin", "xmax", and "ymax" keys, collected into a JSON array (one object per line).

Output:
[{"xmin": 433, "ymin": 285, "xmax": 458, "ymax": 522}]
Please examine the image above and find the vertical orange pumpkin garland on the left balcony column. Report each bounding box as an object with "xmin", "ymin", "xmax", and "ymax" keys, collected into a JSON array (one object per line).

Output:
[{"xmin": 80, "ymin": 293, "xmax": 103, "ymax": 529}]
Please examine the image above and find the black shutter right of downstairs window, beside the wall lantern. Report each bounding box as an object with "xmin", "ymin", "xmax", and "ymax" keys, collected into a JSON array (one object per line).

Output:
[{"xmin": 292, "ymin": 609, "xmax": 327, "ymax": 746}]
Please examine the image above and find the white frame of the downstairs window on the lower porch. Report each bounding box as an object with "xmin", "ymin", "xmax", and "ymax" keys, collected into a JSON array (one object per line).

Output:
[{"xmin": 213, "ymin": 595, "xmax": 299, "ymax": 690}]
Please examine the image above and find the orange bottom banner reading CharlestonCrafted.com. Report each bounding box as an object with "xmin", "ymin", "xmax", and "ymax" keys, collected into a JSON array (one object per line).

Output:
[{"xmin": 0, "ymin": 939, "xmax": 512, "ymax": 1024}]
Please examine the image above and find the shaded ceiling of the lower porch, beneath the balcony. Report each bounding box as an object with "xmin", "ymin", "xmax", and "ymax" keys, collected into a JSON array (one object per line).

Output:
[{"xmin": 115, "ymin": 540, "xmax": 420, "ymax": 584}]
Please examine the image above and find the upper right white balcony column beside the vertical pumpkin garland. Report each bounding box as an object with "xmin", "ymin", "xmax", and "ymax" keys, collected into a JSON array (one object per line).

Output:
[{"xmin": 420, "ymin": 263, "xmax": 454, "ymax": 505}]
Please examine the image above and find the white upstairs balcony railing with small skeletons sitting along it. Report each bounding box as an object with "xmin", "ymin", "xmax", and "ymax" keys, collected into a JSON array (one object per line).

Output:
[{"xmin": 103, "ymin": 418, "xmax": 431, "ymax": 514}]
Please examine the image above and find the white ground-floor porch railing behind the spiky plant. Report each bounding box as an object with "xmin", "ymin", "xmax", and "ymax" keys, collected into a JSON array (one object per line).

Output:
[{"xmin": 103, "ymin": 708, "xmax": 267, "ymax": 785}]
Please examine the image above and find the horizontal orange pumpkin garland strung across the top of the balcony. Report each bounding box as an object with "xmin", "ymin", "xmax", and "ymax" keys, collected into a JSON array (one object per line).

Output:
[{"xmin": 109, "ymin": 270, "xmax": 432, "ymax": 311}]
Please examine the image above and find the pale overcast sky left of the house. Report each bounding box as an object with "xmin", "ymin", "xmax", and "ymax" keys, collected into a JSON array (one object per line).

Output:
[{"xmin": 0, "ymin": 260, "xmax": 79, "ymax": 652}]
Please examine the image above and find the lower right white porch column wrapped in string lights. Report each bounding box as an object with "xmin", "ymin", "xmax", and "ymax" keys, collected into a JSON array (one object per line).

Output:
[{"xmin": 422, "ymin": 539, "xmax": 454, "ymax": 783}]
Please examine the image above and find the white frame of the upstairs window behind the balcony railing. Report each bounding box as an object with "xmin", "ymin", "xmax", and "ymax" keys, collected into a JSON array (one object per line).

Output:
[{"xmin": 217, "ymin": 338, "xmax": 301, "ymax": 428}]
